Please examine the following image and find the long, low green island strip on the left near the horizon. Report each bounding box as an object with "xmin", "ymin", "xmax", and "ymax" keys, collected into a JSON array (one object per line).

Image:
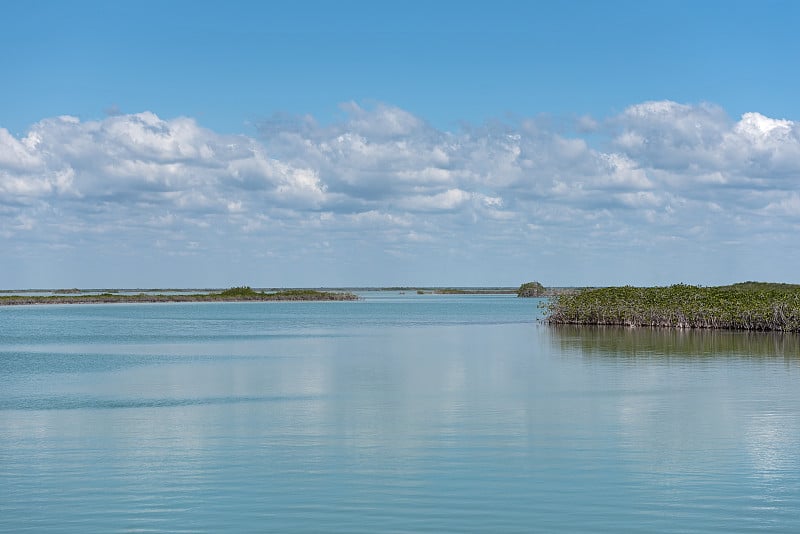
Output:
[{"xmin": 0, "ymin": 286, "xmax": 358, "ymax": 306}]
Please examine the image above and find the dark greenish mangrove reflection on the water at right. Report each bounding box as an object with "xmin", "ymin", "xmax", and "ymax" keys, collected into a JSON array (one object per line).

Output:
[{"xmin": 549, "ymin": 325, "xmax": 800, "ymax": 359}]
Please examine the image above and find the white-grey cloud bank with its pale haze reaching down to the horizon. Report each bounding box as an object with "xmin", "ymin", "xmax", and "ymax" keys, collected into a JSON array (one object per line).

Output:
[{"xmin": 0, "ymin": 101, "xmax": 800, "ymax": 287}]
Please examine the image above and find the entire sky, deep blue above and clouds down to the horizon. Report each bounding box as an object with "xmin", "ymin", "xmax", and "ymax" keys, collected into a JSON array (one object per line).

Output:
[{"xmin": 0, "ymin": 0, "xmax": 800, "ymax": 289}]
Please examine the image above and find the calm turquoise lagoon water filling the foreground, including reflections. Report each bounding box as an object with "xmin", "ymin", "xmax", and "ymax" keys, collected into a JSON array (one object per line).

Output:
[{"xmin": 0, "ymin": 293, "xmax": 800, "ymax": 532}]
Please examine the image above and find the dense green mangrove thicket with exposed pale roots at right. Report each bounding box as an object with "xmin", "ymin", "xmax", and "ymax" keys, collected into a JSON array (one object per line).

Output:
[{"xmin": 543, "ymin": 282, "xmax": 800, "ymax": 332}]
